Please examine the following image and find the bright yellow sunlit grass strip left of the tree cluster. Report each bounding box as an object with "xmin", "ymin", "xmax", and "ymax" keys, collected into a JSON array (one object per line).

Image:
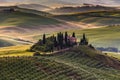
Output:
[{"xmin": 0, "ymin": 45, "xmax": 33, "ymax": 57}]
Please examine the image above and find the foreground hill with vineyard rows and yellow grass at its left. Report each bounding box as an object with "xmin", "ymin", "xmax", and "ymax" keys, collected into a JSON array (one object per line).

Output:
[{"xmin": 0, "ymin": 45, "xmax": 120, "ymax": 80}]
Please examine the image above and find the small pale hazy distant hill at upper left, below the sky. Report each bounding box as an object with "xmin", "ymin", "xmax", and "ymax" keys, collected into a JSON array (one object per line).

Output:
[{"xmin": 17, "ymin": 4, "xmax": 51, "ymax": 11}]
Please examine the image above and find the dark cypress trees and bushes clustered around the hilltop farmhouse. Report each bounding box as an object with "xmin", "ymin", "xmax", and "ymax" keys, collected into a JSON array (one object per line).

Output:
[{"xmin": 30, "ymin": 32, "xmax": 88, "ymax": 52}]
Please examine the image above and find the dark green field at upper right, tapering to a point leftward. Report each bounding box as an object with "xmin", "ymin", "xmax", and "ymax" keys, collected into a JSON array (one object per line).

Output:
[{"xmin": 54, "ymin": 11, "xmax": 120, "ymax": 26}]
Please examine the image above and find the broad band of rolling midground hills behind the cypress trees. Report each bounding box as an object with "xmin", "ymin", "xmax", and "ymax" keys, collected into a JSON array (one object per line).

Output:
[{"xmin": 0, "ymin": 6, "xmax": 120, "ymax": 49}]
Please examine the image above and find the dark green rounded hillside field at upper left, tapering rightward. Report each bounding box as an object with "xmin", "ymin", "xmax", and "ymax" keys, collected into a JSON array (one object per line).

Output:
[{"xmin": 0, "ymin": 11, "xmax": 59, "ymax": 27}]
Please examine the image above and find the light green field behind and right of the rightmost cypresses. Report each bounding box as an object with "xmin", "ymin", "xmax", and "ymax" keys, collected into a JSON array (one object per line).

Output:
[{"xmin": 70, "ymin": 26, "xmax": 120, "ymax": 49}]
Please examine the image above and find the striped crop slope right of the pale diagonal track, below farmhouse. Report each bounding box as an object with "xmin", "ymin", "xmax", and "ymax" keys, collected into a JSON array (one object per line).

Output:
[{"xmin": 41, "ymin": 47, "xmax": 120, "ymax": 80}]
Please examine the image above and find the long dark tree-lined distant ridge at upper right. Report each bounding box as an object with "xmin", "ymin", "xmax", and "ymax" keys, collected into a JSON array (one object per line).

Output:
[{"xmin": 49, "ymin": 5, "xmax": 115, "ymax": 14}]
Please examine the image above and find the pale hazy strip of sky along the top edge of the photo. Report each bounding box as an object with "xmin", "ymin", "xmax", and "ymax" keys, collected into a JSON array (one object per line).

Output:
[{"xmin": 0, "ymin": 0, "xmax": 120, "ymax": 6}]
